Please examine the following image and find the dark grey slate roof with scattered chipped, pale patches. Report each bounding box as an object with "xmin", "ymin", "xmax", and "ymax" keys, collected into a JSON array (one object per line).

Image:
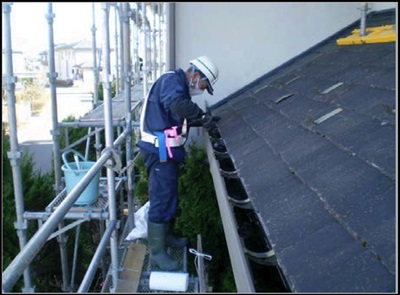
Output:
[{"xmin": 211, "ymin": 10, "xmax": 397, "ymax": 292}]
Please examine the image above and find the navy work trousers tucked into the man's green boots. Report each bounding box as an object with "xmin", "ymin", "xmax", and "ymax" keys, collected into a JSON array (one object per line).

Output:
[{"xmin": 140, "ymin": 148, "xmax": 179, "ymax": 223}]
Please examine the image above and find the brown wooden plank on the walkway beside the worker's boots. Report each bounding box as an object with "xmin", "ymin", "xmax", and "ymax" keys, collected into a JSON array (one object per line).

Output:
[{"xmin": 115, "ymin": 243, "xmax": 147, "ymax": 293}]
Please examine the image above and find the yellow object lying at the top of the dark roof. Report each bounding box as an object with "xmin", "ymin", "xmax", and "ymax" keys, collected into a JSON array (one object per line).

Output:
[{"xmin": 336, "ymin": 25, "xmax": 396, "ymax": 45}]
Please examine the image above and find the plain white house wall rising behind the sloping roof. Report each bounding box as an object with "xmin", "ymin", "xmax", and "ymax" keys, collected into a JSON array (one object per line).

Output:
[{"xmin": 175, "ymin": 2, "xmax": 397, "ymax": 107}]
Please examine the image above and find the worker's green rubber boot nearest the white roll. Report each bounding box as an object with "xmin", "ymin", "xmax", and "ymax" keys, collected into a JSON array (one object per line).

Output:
[{"xmin": 147, "ymin": 222, "xmax": 178, "ymax": 271}]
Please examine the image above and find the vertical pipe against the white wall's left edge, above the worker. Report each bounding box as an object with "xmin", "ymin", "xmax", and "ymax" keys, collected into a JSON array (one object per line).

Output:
[{"xmin": 165, "ymin": 3, "xmax": 176, "ymax": 71}]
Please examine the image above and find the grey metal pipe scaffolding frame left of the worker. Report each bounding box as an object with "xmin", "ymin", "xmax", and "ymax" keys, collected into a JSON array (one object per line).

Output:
[{"xmin": 2, "ymin": 2, "xmax": 173, "ymax": 293}]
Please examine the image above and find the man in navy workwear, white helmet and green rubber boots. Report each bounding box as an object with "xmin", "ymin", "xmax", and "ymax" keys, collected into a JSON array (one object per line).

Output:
[{"xmin": 137, "ymin": 56, "xmax": 219, "ymax": 271}]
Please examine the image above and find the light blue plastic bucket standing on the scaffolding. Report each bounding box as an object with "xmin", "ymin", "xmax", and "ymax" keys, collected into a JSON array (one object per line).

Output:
[{"xmin": 61, "ymin": 149, "xmax": 100, "ymax": 205}]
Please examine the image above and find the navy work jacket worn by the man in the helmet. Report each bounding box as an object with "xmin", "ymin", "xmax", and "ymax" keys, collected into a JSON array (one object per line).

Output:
[{"xmin": 137, "ymin": 68, "xmax": 191, "ymax": 161}]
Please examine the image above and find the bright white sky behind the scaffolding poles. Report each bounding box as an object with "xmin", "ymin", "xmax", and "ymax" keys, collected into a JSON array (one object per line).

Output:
[{"xmin": 2, "ymin": 2, "xmax": 102, "ymax": 55}]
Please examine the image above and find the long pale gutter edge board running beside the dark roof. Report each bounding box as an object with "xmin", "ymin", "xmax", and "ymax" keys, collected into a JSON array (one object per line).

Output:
[{"xmin": 203, "ymin": 132, "xmax": 255, "ymax": 293}]
